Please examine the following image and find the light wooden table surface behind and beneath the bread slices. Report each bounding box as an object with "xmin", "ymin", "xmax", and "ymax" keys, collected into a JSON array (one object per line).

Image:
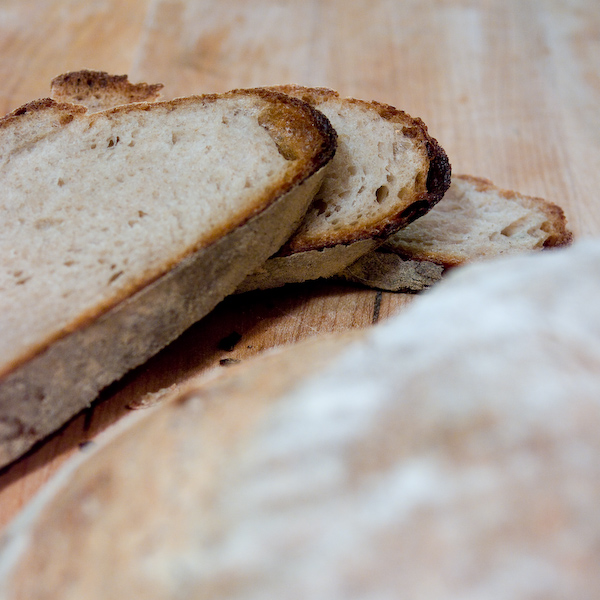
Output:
[{"xmin": 0, "ymin": 0, "xmax": 600, "ymax": 526}]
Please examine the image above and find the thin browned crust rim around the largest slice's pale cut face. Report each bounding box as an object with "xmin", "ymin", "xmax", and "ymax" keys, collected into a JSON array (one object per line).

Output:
[{"xmin": 0, "ymin": 88, "xmax": 337, "ymax": 381}]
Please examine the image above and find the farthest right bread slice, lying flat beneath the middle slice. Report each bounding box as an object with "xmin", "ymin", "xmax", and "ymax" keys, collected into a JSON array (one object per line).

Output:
[{"xmin": 343, "ymin": 175, "xmax": 573, "ymax": 292}]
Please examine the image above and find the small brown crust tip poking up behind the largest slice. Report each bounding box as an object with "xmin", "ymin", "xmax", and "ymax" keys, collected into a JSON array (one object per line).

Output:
[{"xmin": 50, "ymin": 69, "xmax": 163, "ymax": 112}]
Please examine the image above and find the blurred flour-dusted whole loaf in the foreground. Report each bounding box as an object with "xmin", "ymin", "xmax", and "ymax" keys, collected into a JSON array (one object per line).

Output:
[{"xmin": 0, "ymin": 240, "xmax": 600, "ymax": 600}]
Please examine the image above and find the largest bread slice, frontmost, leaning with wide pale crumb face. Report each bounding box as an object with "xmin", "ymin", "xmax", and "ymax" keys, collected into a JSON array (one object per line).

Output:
[{"xmin": 0, "ymin": 90, "xmax": 336, "ymax": 464}]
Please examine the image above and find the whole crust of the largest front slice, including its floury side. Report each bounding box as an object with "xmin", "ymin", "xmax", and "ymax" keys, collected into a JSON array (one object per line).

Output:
[{"xmin": 0, "ymin": 91, "xmax": 336, "ymax": 464}]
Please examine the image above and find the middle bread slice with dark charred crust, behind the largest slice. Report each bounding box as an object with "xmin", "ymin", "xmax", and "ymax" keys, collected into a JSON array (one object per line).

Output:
[{"xmin": 238, "ymin": 85, "xmax": 450, "ymax": 291}]
